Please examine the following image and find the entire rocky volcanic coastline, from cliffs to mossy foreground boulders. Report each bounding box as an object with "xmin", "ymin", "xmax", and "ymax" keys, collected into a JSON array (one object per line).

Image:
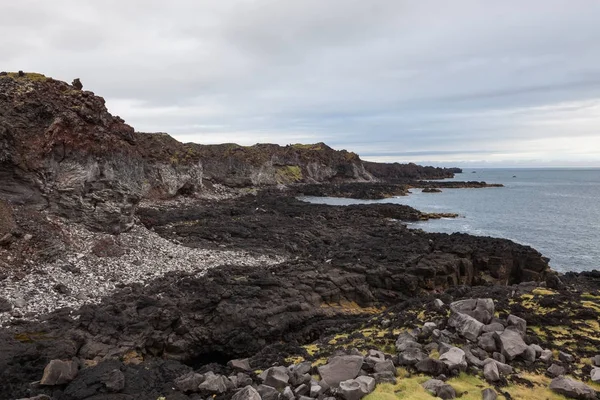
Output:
[{"xmin": 0, "ymin": 73, "xmax": 600, "ymax": 400}]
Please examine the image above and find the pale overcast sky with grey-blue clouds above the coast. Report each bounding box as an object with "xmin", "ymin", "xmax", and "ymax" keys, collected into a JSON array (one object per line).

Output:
[{"xmin": 0, "ymin": 0, "xmax": 600, "ymax": 166}]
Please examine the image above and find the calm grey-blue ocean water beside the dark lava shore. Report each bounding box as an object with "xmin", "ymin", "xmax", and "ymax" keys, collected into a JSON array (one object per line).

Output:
[{"xmin": 303, "ymin": 168, "xmax": 600, "ymax": 272}]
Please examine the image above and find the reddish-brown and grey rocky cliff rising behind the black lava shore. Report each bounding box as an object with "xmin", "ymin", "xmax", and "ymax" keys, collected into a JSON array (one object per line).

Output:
[{"xmin": 0, "ymin": 73, "xmax": 460, "ymax": 232}]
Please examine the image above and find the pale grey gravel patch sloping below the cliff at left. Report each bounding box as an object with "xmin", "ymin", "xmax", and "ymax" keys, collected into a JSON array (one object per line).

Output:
[{"xmin": 0, "ymin": 224, "xmax": 285, "ymax": 326}]
